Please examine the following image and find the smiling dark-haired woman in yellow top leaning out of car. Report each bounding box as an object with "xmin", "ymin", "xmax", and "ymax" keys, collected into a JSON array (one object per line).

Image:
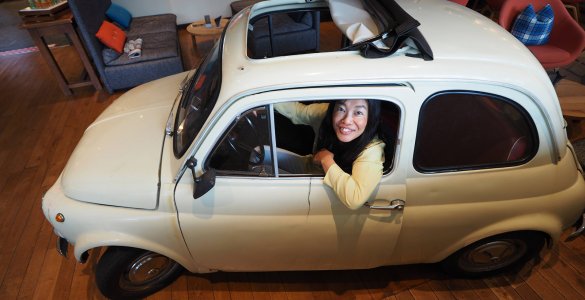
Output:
[{"xmin": 275, "ymin": 99, "xmax": 385, "ymax": 209}]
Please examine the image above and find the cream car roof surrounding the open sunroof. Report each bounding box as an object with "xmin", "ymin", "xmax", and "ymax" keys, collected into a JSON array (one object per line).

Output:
[{"xmin": 222, "ymin": 0, "xmax": 550, "ymax": 98}]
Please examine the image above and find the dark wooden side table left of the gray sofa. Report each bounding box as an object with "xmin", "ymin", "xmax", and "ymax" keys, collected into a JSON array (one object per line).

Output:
[{"xmin": 22, "ymin": 11, "xmax": 102, "ymax": 96}]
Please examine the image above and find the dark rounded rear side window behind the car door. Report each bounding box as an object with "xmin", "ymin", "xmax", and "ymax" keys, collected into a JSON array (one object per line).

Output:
[{"xmin": 413, "ymin": 92, "xmax": 538, "ymax": 172}]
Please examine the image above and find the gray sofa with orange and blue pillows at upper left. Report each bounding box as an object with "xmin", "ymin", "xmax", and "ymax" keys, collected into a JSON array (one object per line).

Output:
[{"xmin": 68, "ymin": 0, "xmax": 183, "ymax": 93}]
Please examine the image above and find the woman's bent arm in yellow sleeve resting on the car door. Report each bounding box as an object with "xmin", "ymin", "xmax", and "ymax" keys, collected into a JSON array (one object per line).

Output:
[{"xmin": 321, "ymin": 142, "xmax": 384, "ymax": 209}]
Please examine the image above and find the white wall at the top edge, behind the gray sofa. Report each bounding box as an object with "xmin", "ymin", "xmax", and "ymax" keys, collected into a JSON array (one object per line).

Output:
[{"xmin": 114, "ymin": 0, "xmax": 234, "ymax": 25}]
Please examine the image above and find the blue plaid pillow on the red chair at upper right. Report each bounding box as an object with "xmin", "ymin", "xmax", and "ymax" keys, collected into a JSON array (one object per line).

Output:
[{"xmin": 511, "ymin": 4, "xmax": 554, "ymax": 46}]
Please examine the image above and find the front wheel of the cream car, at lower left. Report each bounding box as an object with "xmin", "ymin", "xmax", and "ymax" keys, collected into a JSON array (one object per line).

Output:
[{"xmin": 95, "ymin": 247, "xmax": 183, "ymax": 299}]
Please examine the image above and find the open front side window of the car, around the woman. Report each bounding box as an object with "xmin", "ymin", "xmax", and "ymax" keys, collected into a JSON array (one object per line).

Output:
[{"xmin": 207, "ymin": 101, "xmax": 400, "ymax": 177}]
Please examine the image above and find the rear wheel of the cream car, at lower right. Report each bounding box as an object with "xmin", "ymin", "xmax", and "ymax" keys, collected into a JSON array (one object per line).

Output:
[{"xmin": 441, "ymin": 231, "xmax": 545, "ymax": 278}]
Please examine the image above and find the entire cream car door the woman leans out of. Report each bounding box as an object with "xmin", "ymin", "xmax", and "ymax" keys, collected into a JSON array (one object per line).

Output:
[{"xmin": 175, "ymin": 86, "xmax": 413, "ymax": 270}]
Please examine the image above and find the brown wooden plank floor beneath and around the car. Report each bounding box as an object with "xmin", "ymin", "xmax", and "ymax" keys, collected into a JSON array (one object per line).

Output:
[{"xmin": 0, "ymin": 24, "xmax": 585, "ymax": 300}]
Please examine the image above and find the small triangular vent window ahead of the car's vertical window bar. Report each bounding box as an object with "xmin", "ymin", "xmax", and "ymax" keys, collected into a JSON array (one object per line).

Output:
[{"xmin": 209, "ymin": 106, "xmax": 274, "ymax": 176}]
